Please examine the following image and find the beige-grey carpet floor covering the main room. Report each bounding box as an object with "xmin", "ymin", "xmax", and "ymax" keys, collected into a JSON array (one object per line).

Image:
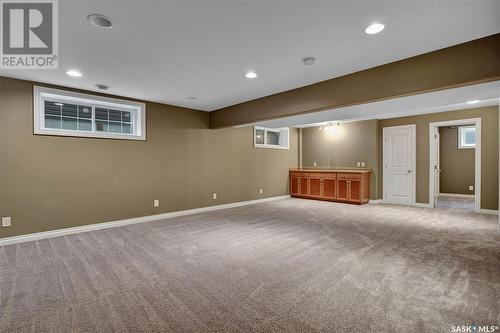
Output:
[{"xmin": 0, "ymin": 199, "xmax": 500, "ymax": 332}]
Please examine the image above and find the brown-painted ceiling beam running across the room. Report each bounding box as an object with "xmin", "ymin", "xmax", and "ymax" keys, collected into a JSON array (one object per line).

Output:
[{"xmin": 210, "ymin": 33, "xmax": 500, "ymax": 128}]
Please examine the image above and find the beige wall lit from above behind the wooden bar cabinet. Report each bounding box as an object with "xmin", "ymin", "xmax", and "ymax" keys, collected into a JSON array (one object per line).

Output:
[{"xmin": 302, "ymin": 120, "xmax": 379, "ymax": 199}]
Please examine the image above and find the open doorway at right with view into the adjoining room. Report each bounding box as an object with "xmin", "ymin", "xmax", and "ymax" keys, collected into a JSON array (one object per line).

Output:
[{"xmin": 429, "ymin": 119, "xmax": 481, "ymax": 212}]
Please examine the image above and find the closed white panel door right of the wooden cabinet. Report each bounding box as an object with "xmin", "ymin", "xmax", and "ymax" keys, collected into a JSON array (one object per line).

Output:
[{"xmin": 383, "ymin": 125, "xmax": 416, "ymax": 205}]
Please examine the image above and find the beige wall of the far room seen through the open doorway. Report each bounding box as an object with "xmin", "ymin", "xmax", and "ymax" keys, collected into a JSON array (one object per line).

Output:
[{"xmin": 439, "ymin": 126, "xmax": 475, "ymax": 194}]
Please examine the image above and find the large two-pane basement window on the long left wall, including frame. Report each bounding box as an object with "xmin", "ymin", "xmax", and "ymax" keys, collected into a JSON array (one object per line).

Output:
[{"xmin": 33, "ymin": 87, "xmax": 146, "ymax": 140}]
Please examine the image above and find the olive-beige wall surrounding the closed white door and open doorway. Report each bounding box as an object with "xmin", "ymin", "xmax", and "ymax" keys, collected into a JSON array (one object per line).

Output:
[{"xmin": 378, "ymin": 106, "xmax": 499, "ymax": 209}]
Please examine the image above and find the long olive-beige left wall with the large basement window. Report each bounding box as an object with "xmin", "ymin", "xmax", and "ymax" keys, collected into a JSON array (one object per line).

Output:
[{"xmin": 0, "ymin": 77, "xmax": 298, "ymax": 237}]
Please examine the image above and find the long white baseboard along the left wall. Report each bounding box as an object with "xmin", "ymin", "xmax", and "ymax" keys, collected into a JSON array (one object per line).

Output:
[{"xmin": 0, "ymin": 195, "xmax": 290, "ymax": 246}]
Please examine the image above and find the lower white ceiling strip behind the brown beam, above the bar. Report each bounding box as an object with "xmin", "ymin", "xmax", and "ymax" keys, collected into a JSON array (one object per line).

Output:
[{"xmin": 256, "ymin": 81, "xmax": 500, "ymax": 128}]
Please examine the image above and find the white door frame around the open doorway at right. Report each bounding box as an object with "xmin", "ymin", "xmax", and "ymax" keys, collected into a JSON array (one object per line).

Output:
[{"xmin": 429, "ymin": 118, "xmax": 481, "ymax": 213}]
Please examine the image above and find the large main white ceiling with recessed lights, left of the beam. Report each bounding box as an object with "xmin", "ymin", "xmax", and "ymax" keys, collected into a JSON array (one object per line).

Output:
[{"xmin": 0, "ymin": 0, "xmax": 500, "ymax": 111}]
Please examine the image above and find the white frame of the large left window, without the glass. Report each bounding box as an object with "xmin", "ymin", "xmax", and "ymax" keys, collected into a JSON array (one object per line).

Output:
[{"xmin": 33, "ymin": 86, "xmax": 146, "ymax": 140}]
